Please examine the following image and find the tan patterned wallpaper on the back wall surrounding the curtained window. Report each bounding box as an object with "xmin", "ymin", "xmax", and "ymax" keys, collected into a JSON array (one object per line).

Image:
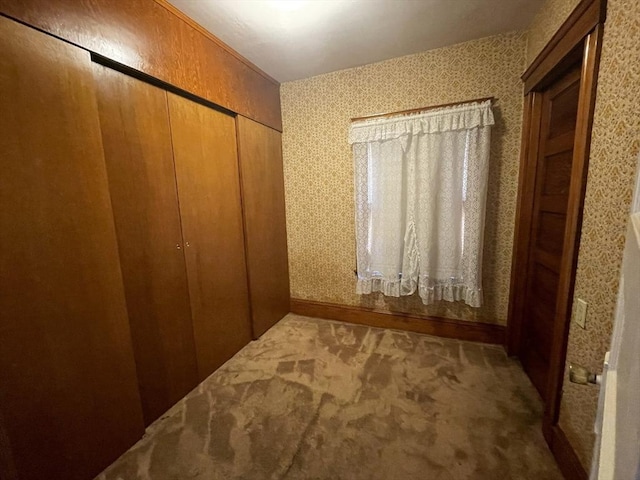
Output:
[{"xmin": 281, "ymin": 33, "xmax": 526, "ymax": 324}]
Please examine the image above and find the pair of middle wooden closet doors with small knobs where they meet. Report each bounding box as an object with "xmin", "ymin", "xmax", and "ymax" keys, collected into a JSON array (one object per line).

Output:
[{"xmin": 94, "ymin": 64, "xmax": 254, "ymax": 424}]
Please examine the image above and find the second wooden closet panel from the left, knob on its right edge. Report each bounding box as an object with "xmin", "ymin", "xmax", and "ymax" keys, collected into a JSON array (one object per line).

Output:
[{"xmin": 93, "ymin": 64, "xmax": 198, "ymax": 425}]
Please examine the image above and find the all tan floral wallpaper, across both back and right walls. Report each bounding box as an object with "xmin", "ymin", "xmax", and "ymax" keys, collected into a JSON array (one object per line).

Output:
[{"xmin": 281, "ymin": 0, "xmax": 640, "ymax": 469}]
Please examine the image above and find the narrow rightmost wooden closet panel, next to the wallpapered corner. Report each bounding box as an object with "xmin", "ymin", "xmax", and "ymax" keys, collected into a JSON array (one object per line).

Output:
[{"xmin": 236, "ymin": 116, "xmax": 289, "ymax": 338}]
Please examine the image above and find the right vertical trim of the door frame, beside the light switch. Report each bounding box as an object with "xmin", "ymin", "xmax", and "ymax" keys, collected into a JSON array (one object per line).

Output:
[{"xmin": 545, "ymin": 24, "xmax": 603, "ymax": 425}]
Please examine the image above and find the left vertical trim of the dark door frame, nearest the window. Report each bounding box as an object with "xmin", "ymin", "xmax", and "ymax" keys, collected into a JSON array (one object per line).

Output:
[{"xmin": 507, "ymin": 92, "xmax": 542, "ymax": 355}]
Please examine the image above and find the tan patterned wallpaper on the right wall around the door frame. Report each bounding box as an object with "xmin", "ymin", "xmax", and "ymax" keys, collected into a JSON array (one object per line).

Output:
[{"xmin": 530, "ymin": 0, "xmax": 640, "ymax": 469}]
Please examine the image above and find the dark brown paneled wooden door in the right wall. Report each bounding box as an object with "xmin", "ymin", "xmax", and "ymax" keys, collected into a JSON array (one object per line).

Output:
[{"xmin": 520, "ymin": 69, "xmax": 580, "ymax": 398}]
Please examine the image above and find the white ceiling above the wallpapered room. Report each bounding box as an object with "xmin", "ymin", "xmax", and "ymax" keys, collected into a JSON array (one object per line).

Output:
[{"xmin": 169, "ymin": 0, "xmax": 544, "ymax": 82}]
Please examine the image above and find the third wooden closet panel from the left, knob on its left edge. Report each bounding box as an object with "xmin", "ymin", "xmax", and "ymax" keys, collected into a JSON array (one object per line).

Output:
[{"xmin": 167, "ymin": 93, "xmax": 251, "ymax": 380}]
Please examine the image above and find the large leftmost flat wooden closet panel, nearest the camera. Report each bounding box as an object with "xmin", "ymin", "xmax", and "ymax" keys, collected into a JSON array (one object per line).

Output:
[{"xmin": 0, "ymin": 17, "xmax": 144, "ymax": 480}]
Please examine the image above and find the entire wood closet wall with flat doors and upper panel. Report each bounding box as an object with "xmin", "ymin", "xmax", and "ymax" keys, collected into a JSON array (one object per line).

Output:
[{"xmin": 0, "ymin": 0, "xmax": 289, "ymax": 480}]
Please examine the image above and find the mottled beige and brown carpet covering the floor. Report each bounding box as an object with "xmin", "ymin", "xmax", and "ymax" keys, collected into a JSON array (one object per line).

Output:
[{"xmin": 98, "ymin": 315, "xmax": 562, "ymax": 480}]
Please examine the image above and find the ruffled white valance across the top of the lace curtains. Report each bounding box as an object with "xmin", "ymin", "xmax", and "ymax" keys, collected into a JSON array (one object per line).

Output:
[{"xmin": 349, "ymin": 100, "xmax": 495, "ymax": 145}]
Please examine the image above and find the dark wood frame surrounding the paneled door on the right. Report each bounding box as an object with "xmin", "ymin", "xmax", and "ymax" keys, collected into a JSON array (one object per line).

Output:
[{"xmin": 508, "ymin": 0, "xmax": 607, "ymax": 468}]
